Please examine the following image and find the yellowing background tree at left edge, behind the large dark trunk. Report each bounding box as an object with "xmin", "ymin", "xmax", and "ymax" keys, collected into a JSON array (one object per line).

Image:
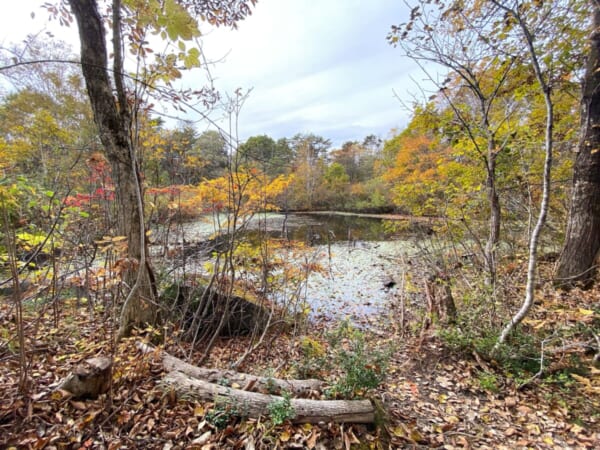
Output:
[{"xmin": 0, "ymin": 36, "xmax": 96, "ymax": 183}]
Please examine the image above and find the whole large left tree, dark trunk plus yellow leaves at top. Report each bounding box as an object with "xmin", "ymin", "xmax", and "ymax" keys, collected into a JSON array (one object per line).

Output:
[{"xmin": 61, "ymin": 0, "xmax": 253, "ymax": 335}]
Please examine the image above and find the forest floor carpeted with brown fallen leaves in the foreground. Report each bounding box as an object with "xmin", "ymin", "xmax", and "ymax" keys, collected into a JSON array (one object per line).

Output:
[{"xmin": 0, "ymin": 266, "xmax": 600, "ymax": 450}]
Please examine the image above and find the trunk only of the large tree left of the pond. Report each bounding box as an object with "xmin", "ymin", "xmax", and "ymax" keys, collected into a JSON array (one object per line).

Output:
[{"xmin": 69, "ymin": 0, "xmax": 157, "ymax": 335}]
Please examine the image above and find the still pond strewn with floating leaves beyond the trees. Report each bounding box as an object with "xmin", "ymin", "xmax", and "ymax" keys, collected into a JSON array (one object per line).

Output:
[{"xmin": 158, "ymin": 213, "xmax": 426, "ymax": 324}]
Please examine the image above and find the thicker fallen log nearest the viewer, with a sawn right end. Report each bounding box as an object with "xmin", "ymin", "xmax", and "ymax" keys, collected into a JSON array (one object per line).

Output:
[{"xmin": 162, "ymin": 371, "xmax": 375, "ymax": 423}]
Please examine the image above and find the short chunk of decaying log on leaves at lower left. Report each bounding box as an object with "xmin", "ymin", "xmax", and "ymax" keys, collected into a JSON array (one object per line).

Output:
[{"xmin": 58, "ymin": 356, "xmax": 112, "ymax": 398}]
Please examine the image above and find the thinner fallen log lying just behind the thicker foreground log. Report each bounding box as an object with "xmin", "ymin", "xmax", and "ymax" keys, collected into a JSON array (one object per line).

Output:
[{"xmin": 136, "ymin": 342, "xmax": 325, "ymax": 395}]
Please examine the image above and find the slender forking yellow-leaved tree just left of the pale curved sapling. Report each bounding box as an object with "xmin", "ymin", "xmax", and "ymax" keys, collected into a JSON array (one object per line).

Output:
[{"xmin": 388, "ymin": 1, "xmax": 514, "ymax": 284}]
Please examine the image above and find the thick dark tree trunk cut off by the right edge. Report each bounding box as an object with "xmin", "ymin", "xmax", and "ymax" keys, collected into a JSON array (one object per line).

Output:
[{"xmin": 555, "ymin": 1, "xmax": 600, "ymax": 286}]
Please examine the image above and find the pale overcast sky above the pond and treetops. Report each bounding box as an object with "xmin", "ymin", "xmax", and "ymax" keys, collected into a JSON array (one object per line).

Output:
[{"xmin": 0, "ymin": 0, "xmax": 423, "ymax": 146}]
